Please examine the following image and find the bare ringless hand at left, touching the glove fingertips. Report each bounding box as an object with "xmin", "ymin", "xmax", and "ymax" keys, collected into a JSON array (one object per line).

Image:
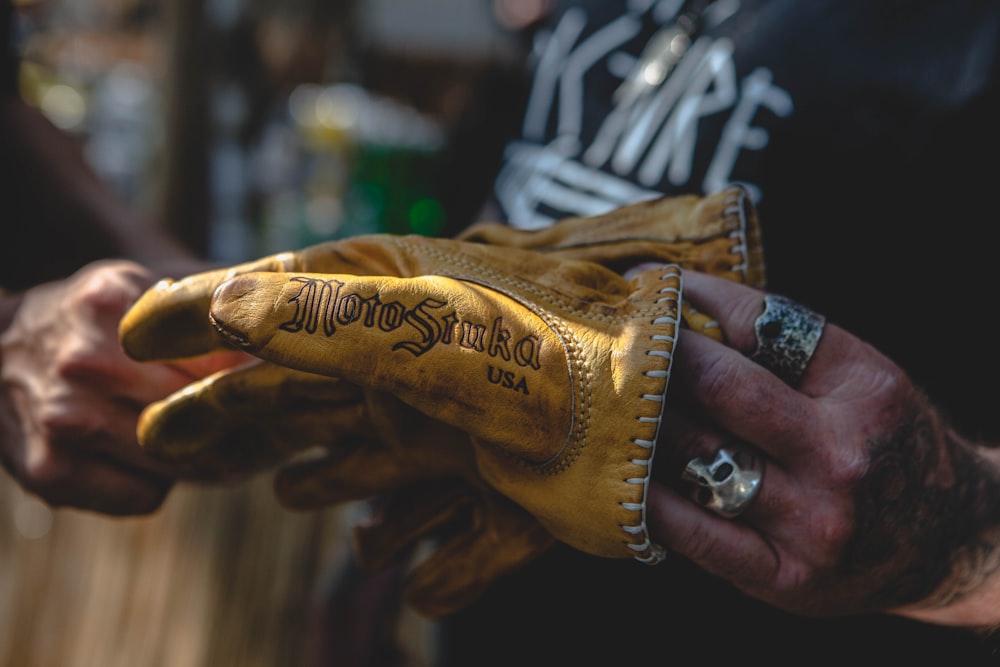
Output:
[{"xmin": 0, "ymin": 261, "xmax": 244, "ymax": 515}]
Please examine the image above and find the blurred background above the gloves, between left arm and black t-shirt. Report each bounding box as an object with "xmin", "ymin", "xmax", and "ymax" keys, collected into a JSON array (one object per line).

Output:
[{"xmin": 9, "ymin": 0, "xmax": 546, "ymax": 261}]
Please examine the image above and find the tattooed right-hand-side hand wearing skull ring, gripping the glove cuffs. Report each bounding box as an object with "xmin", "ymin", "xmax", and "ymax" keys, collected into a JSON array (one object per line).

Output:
[{"xmin": 649, "ymin": 272, "xmax": 1000, "ymax": 625}]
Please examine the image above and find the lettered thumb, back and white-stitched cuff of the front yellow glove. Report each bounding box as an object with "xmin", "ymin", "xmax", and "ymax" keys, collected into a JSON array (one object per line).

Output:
[{"xmin": 125, "ymin": 230, "xmax": 681, "ymax": 559}]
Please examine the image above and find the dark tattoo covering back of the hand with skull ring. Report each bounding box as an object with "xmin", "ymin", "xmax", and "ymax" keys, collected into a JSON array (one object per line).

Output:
[{"xmin": 842, "ymin": 400, "xmax": 1000, "ymax": 609}]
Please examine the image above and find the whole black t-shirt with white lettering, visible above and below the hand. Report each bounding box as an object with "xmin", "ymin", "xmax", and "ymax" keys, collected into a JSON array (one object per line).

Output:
[{"xmin": 443, "ymin": 0, "xmax": 1000, "ymax": 666}]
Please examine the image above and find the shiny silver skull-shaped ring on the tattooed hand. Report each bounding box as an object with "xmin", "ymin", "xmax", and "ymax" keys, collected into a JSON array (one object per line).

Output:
[{"xmin": 683, "ymin": 448, "xmax": 763, "ymax": 518}]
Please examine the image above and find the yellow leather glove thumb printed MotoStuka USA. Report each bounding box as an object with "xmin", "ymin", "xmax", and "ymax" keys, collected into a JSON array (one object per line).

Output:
[{"xmin": 211, "ymin": 273, "xmax": 572, "ymax": 463}]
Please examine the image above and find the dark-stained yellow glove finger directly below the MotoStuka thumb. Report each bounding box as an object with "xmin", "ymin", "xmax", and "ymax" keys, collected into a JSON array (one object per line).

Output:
[{"xmin": 138, "ymin": 360, "xmax": 366, "ymax": 473}]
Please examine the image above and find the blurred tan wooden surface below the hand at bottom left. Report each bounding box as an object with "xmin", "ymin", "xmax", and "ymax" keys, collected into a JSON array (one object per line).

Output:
[{"xmin": 0, "ymin": 475, "xmax": 434, "ymax": 667}]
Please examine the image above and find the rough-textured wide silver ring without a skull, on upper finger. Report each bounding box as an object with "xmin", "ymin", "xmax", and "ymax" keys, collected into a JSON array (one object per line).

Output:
[{"xmin": 750, "ymin": 294, "xmax": 826, "ymax": 387}]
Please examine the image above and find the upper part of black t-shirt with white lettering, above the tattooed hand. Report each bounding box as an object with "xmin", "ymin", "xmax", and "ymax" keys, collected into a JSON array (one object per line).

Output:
[{"xmin": 495, "ymin": 0, "xmax": 1000, "ymax": 439}]
